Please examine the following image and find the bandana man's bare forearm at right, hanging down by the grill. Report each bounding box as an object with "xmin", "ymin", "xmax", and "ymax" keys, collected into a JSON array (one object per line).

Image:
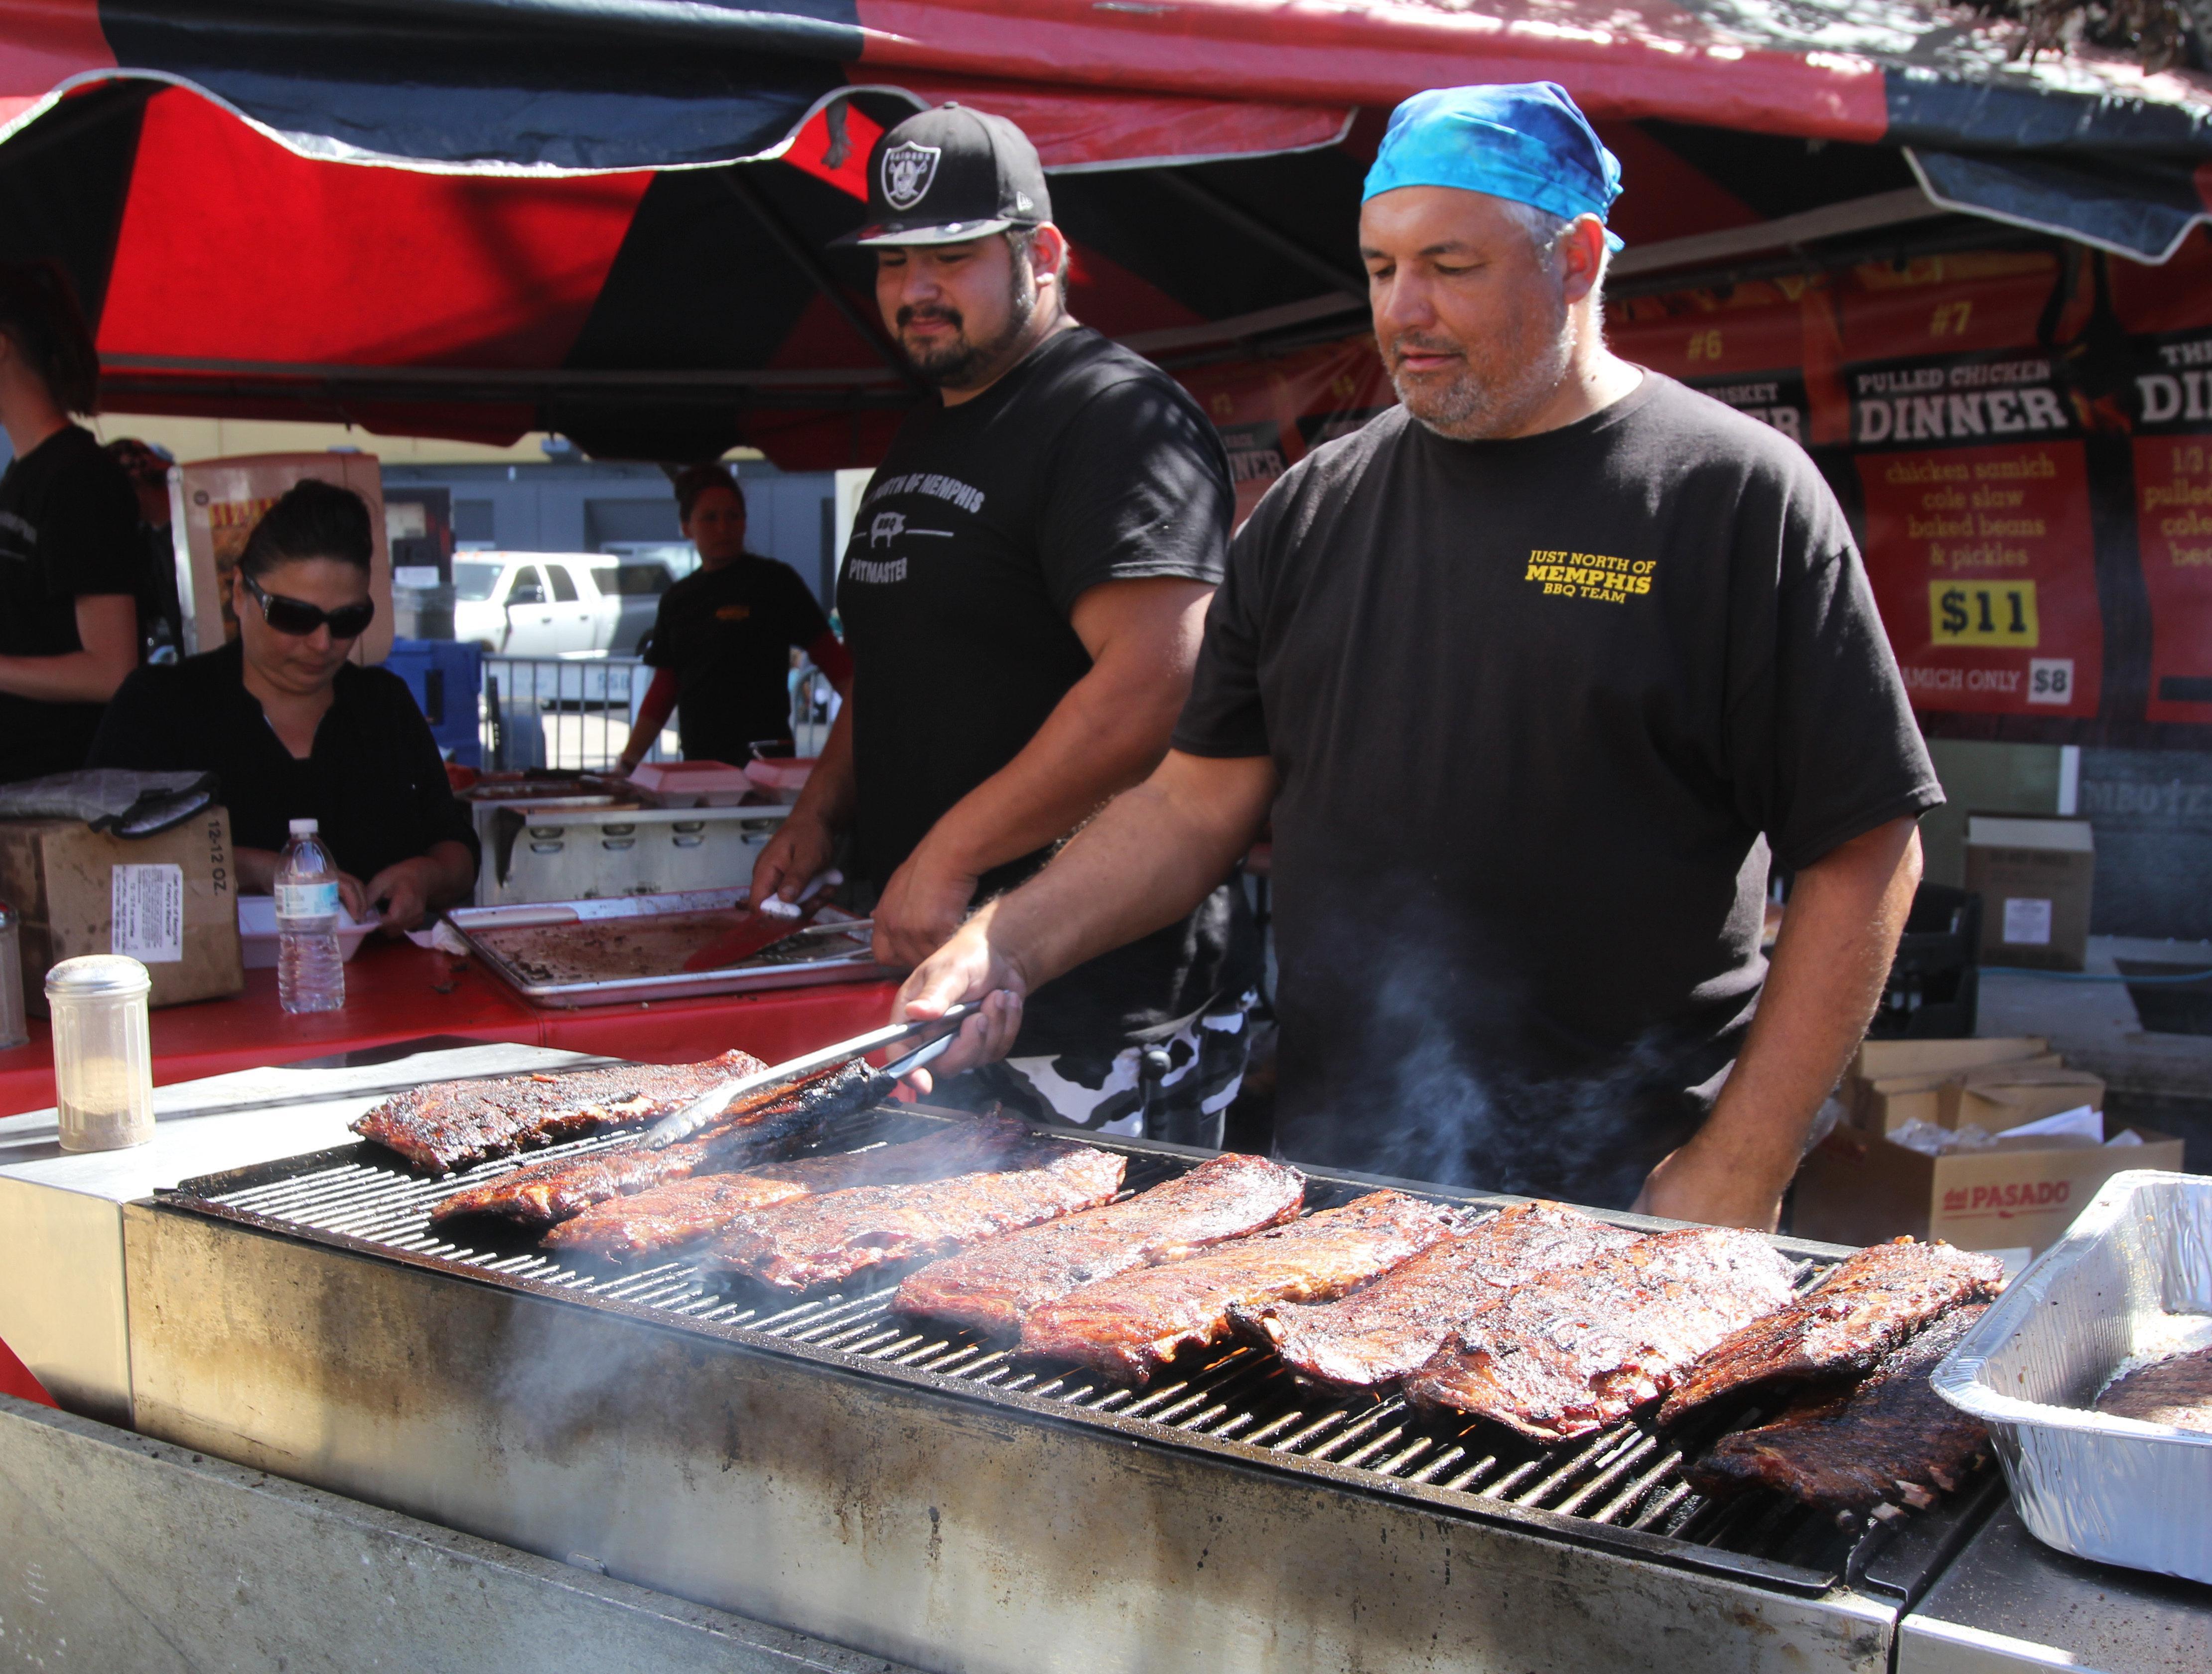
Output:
[{"xmin": 1641, "ymin": 818, "xmax": 1920, "ymax": 1227}]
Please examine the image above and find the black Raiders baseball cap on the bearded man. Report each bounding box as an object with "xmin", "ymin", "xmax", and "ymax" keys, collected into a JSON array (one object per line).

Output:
[{"xmin": 838, "ymin": 104, "xmax": 1053, "ymax": 246}]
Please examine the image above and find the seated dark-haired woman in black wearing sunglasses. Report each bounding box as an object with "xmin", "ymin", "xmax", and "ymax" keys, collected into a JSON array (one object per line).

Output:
[{"xmin": 91, "ymin": 478, "xmax": 478, "ymax": 933}]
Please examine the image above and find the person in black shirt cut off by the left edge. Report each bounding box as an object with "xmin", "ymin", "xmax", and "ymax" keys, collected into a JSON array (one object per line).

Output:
[{"xmin": 0, "ymin": 261, "xmax": 146, "ymax": 783}]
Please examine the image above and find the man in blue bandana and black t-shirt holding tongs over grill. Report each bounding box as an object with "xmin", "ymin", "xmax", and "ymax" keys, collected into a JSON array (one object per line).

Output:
[{"xmin": 903, "ymin": 82, "xmax": 1942, "ymax": 1227}]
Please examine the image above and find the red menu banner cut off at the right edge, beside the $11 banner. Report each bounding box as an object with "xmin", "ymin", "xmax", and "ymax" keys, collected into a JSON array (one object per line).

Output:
[{"xmin": 2130, "ymin": 332, "xmax": 2212, "ymax": 721}]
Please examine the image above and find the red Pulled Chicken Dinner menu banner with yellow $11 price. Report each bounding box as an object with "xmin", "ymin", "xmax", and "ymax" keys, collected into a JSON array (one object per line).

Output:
[{"xmin": 1845, "ymin": 354, "xmax": 2103, "ymax": 716}]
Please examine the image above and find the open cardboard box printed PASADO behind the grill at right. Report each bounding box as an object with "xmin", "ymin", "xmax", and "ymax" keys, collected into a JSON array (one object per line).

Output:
[{"xmin": 1790, "ymin": 1115, "xmax": 2181, "ymax": 1260}]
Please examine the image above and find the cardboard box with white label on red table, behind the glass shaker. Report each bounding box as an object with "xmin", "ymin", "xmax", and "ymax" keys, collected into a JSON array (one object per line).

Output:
[{"xmin": 0, "ymin": 807, "xmax": 246, "ymax": 1017}]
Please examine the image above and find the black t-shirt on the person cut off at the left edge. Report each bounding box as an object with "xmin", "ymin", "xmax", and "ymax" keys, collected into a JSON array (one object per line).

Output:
[{"xmin": 0, "ymin": 424, "xmax": 146, "ymax": 783}]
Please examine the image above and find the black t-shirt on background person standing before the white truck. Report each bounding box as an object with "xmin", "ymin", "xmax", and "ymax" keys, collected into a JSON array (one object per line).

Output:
[{"xmin": 646, "ymin": 553, "xmax": 830, "ymax": 765}]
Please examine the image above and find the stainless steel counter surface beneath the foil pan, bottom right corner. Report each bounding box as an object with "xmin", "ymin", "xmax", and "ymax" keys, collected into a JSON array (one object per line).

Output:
[{"xmin": 1896, "ymin": 1506, "xmax": 2212, "ymax": 1674}]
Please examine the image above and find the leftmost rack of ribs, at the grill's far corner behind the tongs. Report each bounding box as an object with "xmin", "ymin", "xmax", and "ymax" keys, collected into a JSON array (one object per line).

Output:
[{"xmin": 352, "ymin": 1050, "xmax": 768, "ymax": 1174}]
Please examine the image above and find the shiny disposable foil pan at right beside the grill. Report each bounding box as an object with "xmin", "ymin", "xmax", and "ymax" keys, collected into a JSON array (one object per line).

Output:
[{"xmin": 1934, "ymin": 1170, "xmax": 2212, "ymax": 1581}]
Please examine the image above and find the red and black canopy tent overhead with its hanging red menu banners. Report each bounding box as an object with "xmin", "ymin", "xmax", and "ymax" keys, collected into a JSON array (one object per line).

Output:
[{"xmin": 0, "ymin": 0, "xmax": 2212, "ymax": 747}]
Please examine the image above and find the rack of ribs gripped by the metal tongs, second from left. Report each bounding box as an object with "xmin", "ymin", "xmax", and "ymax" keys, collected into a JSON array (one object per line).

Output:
[{"xmin": 429, "ymin": 1064, "xmax": 880, "ymax": 1230}]
